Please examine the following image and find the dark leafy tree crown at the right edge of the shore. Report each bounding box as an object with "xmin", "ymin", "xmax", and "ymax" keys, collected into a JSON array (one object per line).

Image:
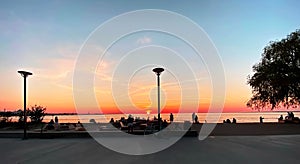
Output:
[{"xmin": 247, "ymin": 30, "xmax": 300, "ymax": 109}]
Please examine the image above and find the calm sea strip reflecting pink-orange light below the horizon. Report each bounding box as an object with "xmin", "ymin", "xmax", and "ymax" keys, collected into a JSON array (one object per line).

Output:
[{"xmin": 35, "ymin": 112, "xmax": 300, "ymax": 123}]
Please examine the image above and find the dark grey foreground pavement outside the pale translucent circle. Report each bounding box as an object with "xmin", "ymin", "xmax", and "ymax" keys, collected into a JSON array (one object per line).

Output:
[{"xmin": 0, "ymin": 135, "xmax": 300, "ymax": 164}]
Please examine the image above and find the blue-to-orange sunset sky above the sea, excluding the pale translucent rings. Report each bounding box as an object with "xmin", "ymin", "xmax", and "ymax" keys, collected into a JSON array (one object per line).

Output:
[{"xmin": 0, "ymin": 0, "xmax": 300, "ymax": 113}]
